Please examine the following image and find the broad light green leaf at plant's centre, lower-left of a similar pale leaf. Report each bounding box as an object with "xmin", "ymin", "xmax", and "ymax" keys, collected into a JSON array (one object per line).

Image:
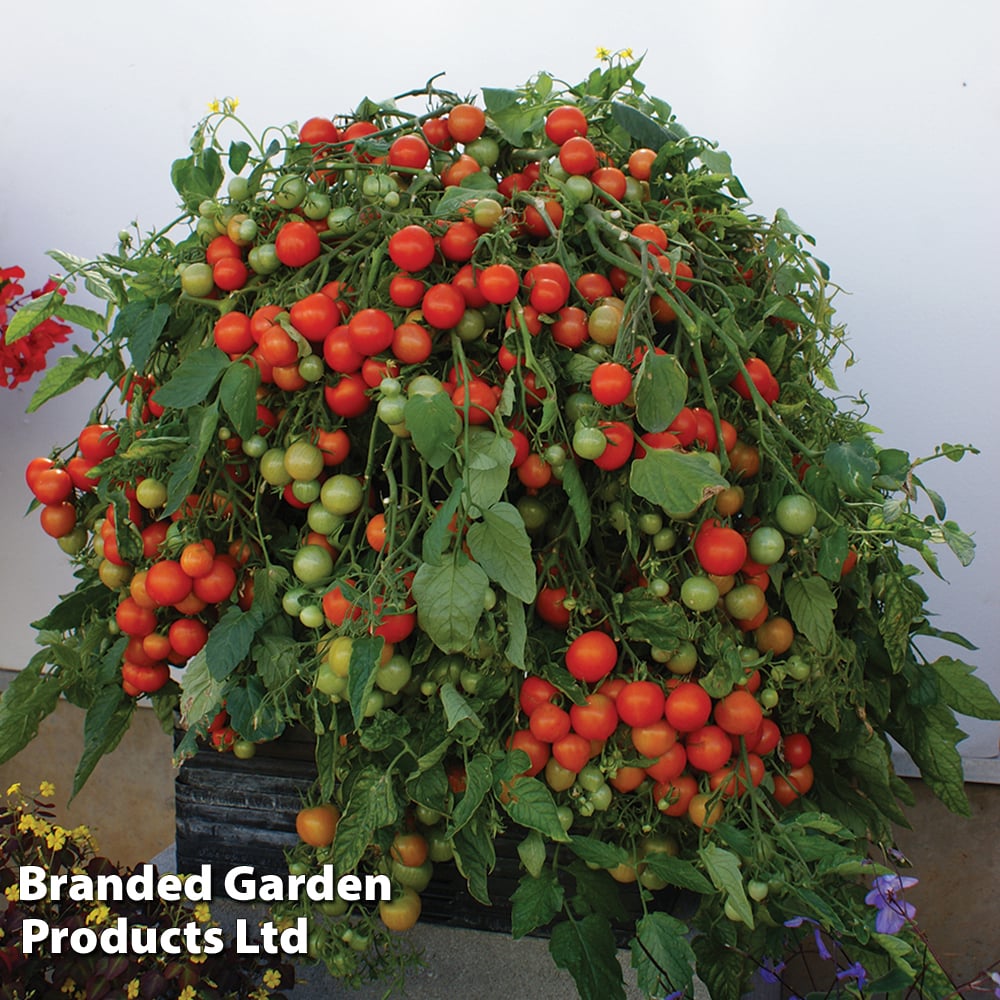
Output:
[{"xmin": 412, "ymin": 554, "xmax": 490, "ymax": 653}]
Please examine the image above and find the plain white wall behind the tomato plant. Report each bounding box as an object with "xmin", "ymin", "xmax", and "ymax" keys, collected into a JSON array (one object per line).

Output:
[{"xmin": 0, "ymin": 0, "xmax": 1000, "ymax": 756}]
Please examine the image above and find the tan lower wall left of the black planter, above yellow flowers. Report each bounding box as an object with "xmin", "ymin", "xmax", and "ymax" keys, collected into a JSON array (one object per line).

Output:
[{"xmin": 0, "ymin": 685, "xmax": 174, "ymax": 866}]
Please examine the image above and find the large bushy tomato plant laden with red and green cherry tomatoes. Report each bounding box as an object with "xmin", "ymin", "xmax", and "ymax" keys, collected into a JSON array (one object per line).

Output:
[{"xmin": 0, "ymin": 56, "xmax": 1000, "ymax": 1000}]
